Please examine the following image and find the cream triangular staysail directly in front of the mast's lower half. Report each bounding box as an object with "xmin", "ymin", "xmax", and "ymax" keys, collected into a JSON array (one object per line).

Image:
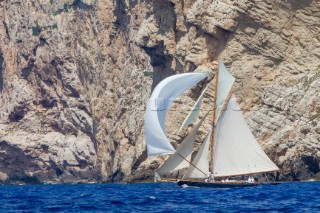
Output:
[{"xmin": 183, "ymin": 130, "xmax": 211, "ymax": 179}]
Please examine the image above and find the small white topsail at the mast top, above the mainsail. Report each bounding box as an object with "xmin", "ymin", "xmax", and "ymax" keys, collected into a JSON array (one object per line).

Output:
[{"xmin": 215, "ymin": 60, "xmax": 235, "ymax": 122}]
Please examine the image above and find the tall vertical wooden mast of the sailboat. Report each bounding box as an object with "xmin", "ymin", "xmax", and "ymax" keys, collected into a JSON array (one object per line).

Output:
[{"xmin": 209, "ymin": 57, "xmax": 220, "ymax": 174}]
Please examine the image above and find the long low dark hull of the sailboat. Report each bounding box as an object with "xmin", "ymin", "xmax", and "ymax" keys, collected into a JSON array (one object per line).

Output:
[{"xmin": 177, "ymin": 180, "xmax": 261, "ymax": 188}]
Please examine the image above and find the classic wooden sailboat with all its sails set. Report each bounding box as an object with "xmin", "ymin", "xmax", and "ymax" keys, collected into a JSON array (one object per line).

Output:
[{"xmin": 145, "ymin": 61, "xmax": 279, "ymax": 188}]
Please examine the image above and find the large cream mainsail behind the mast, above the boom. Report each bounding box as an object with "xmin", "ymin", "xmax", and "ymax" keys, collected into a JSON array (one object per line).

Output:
[{"xmin": 213, "ymin": 95, "xmax": 279, "ymax": 177}]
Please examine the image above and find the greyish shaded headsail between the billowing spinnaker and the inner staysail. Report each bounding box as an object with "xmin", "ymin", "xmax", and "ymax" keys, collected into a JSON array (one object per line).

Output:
[{"xmin": 156, "ymin": 114, "xmax": 208, "ymax": 175}]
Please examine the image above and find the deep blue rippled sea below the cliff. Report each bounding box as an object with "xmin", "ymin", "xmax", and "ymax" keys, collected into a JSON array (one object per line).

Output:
[{"xmin": 0, "ymin": 182, "xmax": 320, "ymax": 213}]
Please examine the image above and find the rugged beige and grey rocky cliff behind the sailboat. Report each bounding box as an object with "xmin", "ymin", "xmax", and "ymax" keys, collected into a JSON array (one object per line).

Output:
[{"xmin": 0, "ymin": 0, "xmax": 320, "ymax": 183}]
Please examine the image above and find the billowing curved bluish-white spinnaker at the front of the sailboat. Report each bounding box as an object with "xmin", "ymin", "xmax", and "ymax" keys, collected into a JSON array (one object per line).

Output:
[{"xmin": 144, "ymin": 73, "xmax": 207, "ymax": 156}]
